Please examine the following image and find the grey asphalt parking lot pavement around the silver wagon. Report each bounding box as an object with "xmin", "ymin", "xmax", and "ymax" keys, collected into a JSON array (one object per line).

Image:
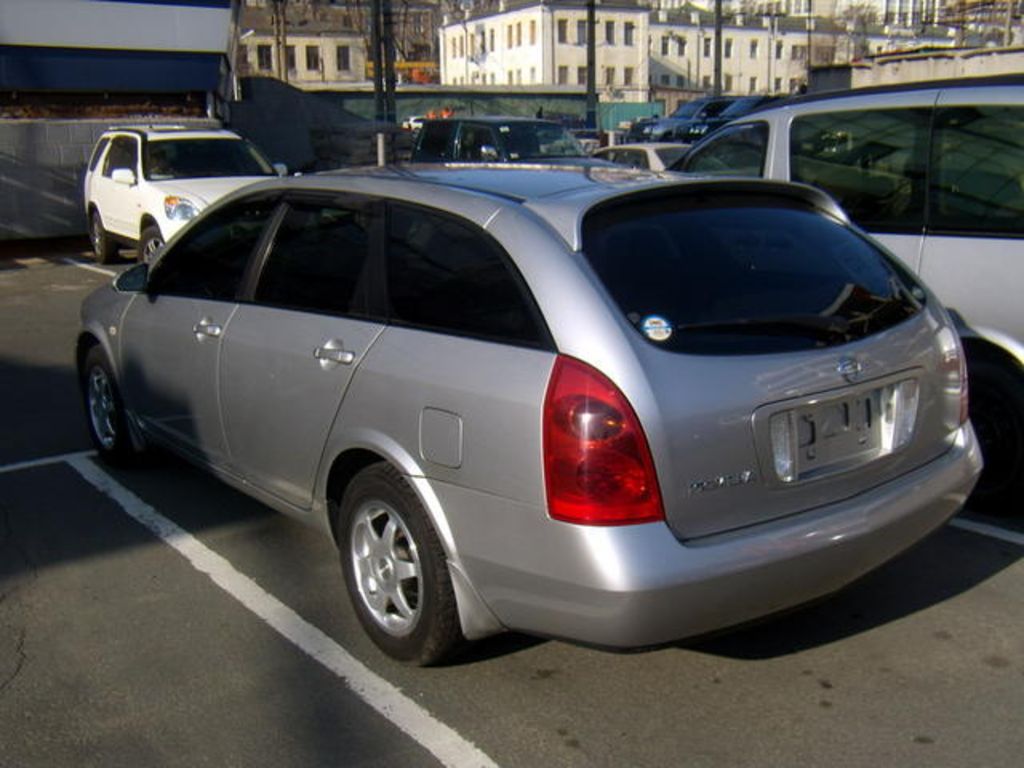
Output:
[{"xmin": 0, "ymin": 241, "xmax": 1024, "ymax": 768}]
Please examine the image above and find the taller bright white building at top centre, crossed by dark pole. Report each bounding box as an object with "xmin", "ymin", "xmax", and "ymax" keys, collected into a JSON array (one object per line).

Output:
[{"xmin": 438, "ymin": 0, "xmax": 649, "ymax": 101}]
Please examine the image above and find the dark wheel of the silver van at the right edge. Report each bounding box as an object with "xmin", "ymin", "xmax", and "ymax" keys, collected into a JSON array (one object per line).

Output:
[{"xmin": 968, "ymin": 359, "xmax": 1024, "ymax": 516}]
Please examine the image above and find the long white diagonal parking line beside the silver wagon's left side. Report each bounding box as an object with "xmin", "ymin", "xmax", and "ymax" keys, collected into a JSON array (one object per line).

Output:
[{"xmin": 62, "ymin": 455, "xmax": 497, "ymax": 768}]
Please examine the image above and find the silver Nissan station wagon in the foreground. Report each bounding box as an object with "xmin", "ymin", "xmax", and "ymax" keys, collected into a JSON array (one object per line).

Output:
[{"xmin": 78, "ymin": 166, "xmax": 981, "ymax": 664}]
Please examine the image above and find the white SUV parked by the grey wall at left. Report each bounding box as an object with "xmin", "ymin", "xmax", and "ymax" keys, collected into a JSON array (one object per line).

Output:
[{"xmin": 85, "ymin": 126, "xmax": 285, "ymax": 263}]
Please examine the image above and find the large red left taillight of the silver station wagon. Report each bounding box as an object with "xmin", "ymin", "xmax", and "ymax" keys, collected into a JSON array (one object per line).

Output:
[{"xmin": 544, "ymin": 356, "xmax": 665, "ymax": 525}]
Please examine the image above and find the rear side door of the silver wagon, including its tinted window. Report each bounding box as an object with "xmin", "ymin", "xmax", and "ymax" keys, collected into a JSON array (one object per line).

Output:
[{"xmin": 220, "ymin": 197, "xmax": 383, "ymax": 508}]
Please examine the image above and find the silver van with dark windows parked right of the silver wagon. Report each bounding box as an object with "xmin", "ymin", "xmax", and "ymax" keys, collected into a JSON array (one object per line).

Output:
[{"xmin": 680, "ymin": 76, "xmax": 1024, "ymax": 513}]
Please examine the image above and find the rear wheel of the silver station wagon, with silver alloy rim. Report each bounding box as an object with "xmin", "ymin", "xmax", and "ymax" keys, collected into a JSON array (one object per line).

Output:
[{"xmin": 337, "ymin": 463, "xmax": 464, "ymax": 667}]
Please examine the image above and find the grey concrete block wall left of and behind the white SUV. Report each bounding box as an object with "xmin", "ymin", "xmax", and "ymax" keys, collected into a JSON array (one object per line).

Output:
[{"xmin": 0, "ymin": 119, "xmax": 210, "ymax": 240}]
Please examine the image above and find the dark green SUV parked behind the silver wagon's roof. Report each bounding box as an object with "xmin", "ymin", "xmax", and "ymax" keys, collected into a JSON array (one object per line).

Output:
[{"xmin": 412, "ymin": 117, "xmax": 594, "ymax": 165}]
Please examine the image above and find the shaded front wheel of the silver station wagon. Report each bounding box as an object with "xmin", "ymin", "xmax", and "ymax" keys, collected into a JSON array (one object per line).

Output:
[{"xmin": 79, "ymin": 344, "xmax": 139, "ymax": 466}]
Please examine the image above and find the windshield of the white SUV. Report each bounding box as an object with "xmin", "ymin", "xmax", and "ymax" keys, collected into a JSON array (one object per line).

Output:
[{"xmin": 142, "ymin": 138, "xmax": 276, "ymax": 181}]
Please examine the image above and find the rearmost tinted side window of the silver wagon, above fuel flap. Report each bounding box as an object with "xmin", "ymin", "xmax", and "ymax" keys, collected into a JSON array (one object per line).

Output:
[{"xmin": 387, "ymin": 205, "xmax": 545, "ymax": 346}]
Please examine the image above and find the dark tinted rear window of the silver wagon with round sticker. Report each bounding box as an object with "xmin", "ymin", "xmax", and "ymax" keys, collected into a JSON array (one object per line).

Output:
[{"xmin": 583, "ymin": 193, "xmax": 925, "ymax": 354}]
